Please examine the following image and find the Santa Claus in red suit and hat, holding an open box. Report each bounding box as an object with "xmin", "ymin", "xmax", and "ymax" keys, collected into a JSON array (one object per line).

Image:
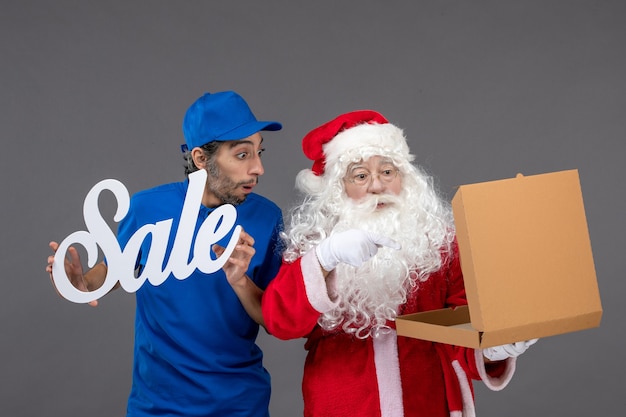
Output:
[{"xmin": 262, "ymin": 110, "xmax": 533, "ymax": 417}]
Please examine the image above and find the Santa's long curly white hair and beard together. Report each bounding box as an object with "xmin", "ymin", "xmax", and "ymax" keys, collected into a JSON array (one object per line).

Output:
[{"xmin": 283, "ymin": 123, "xmax": 455, "ymax": 338}]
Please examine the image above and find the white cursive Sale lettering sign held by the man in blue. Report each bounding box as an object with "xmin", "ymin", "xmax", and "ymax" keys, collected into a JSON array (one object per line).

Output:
[{"xmin": 52, "ymin": 170, "xmax": 241, "ymax": 303}]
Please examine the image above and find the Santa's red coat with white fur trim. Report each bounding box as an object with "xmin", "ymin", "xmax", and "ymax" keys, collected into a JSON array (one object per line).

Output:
[{"xmin": 262, "ymin": 242, "xmax": 515, "ymax": 417}]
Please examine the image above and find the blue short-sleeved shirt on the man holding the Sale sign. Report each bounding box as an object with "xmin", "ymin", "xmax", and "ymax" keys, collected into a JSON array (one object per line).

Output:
[{"xmin": 118, "ymin": 181, "xmax": 283, "ymax": 417}]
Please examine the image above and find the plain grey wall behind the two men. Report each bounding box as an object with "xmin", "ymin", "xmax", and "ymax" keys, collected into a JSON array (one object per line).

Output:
[{"xmin": 0, "ymin": 0, "xmax": 626, "ymax": 417}]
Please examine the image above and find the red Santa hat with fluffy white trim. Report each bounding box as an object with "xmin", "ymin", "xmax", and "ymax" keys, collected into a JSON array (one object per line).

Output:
[{"xmin": 302, "ymin": 110, "xmax": 412, "ymax": 176}]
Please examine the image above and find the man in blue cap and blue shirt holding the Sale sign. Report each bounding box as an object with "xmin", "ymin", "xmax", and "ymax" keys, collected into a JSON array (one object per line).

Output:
[{"xmin": 47, "ymin": 91, "xmax": 282, "ymax": 417}]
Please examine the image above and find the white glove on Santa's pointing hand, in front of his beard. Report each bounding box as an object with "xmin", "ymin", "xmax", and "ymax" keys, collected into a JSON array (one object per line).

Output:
[{"xmin": 315, "ymin": 229, "xmax": 400, "ymax": 271}]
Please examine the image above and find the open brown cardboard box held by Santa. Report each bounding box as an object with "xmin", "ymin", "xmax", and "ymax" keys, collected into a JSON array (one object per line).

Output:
[{"xmin": 396, "ymin": 170, "xmax": 602, "ymax": 348}]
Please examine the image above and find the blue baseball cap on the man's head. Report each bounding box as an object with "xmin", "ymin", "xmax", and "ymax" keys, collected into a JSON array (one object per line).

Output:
[{"xmin": 183, "ymin": 91, "xmax": 283, "ymax": 150}]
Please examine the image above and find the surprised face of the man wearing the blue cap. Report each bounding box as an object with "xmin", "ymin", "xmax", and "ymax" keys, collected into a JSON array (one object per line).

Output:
[{"xmin": 203, "ymin": 133, "xmax": 265, "ymax": 207}]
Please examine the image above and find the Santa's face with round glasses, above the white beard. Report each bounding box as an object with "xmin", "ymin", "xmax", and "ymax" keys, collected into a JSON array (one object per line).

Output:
[{"xmin": 344, "ymin": 156, "xmax": 402, "ymax": 203}]
